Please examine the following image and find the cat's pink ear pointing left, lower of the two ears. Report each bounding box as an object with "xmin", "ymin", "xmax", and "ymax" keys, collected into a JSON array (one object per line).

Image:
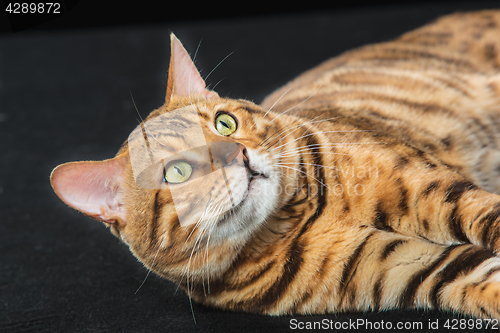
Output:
[{"xmin": 51, "ymin": 158, "xmax": 125, "ymax": 223}]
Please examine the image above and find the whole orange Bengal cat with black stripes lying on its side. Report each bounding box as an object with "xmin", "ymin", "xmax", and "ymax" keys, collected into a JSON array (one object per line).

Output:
[{"xmin": 51, "ymin": 11, "xmax": 500, "ymax": 319}]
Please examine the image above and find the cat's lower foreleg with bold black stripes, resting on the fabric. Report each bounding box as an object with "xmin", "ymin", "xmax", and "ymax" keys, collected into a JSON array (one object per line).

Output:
[{"xmin": 337, "ymin": 231, "xmax": 500, "ymax": 319}]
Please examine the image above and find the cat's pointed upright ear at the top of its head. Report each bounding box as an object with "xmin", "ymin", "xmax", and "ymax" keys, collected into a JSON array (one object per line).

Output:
[{"xmin": 165, "ymin": 34, "xmax": 219, "ymax": 104}]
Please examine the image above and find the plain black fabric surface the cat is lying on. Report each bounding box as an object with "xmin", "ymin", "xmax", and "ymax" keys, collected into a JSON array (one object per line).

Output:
[{"xmin": 0, "ymin": 1, "xmax": 500, "ymax": 332}]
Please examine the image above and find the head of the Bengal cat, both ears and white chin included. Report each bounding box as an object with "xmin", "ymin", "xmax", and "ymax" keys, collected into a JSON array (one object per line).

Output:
[{"xmin": 51, "ymin": 35, "xmax": 294, "ymax": 280}]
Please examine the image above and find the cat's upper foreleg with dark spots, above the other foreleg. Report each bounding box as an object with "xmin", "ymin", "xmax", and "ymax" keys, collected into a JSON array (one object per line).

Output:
[{"xmin": 352, "ymin": 143, "xmax": 500, "ymax": 254}]
